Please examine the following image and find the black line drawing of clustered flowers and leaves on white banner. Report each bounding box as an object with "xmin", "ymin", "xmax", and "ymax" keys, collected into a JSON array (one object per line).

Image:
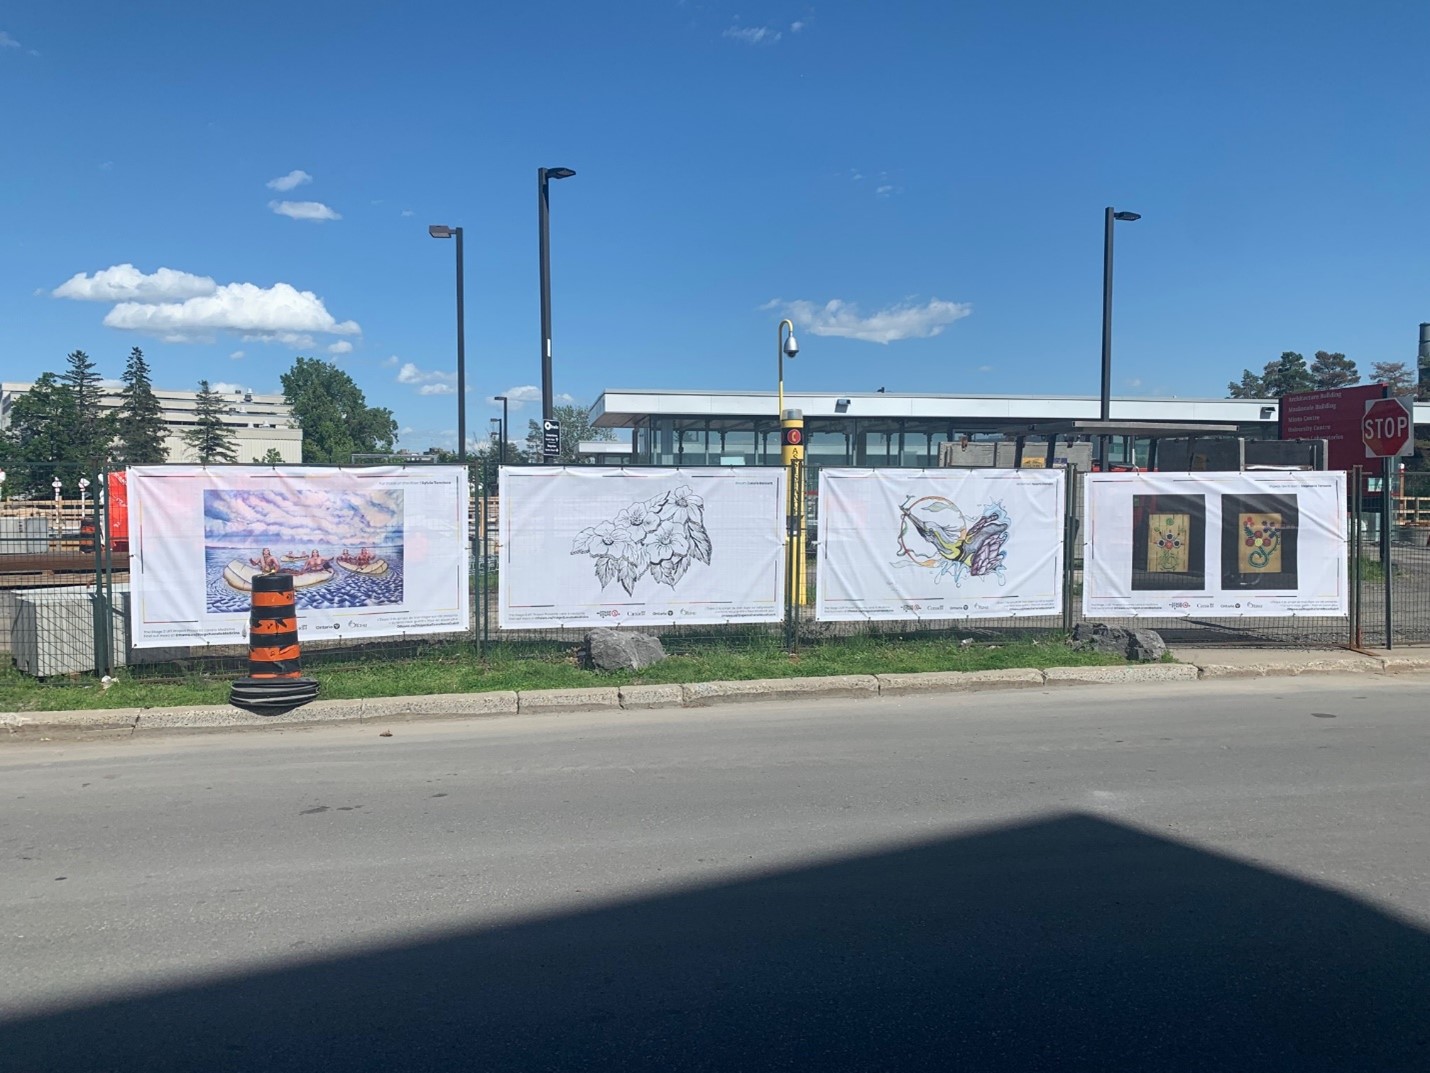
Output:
[{"xmin": 571, "ymin": 485, "xmax": 714, "ymax": 595}]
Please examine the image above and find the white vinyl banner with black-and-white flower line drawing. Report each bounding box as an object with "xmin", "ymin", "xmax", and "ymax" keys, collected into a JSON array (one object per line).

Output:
[{"xmin": 498, "ymin": 466, "xmax": 787, "ymax": 629}]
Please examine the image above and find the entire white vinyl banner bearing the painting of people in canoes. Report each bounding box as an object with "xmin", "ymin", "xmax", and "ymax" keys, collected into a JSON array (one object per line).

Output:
[{"xmin": 127, "ymin": 465, "xmax": 470, "ymax": 648}]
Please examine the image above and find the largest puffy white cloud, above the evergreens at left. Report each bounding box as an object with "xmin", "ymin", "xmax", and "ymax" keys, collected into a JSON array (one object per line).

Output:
[{"xmin": 104, "ymin": 283, "xmax": 362, "ymax": 346}]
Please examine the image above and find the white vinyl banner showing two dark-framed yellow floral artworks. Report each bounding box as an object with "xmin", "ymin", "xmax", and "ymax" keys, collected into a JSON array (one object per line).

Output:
[{"xmin": 1083, "ymin": 471, "xmax": 1348, "ymax": 618}]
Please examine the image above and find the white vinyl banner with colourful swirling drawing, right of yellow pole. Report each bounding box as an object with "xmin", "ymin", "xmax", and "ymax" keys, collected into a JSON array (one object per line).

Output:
[{"xmin": 815, "ymin": 469, "xmax": 1064, "ymax": 621}]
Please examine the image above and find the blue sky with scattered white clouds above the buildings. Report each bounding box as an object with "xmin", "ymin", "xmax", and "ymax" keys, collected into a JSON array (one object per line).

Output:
[{"xmin": 8, "ymin": 0, "xmax": 1430, "ymax": 449}]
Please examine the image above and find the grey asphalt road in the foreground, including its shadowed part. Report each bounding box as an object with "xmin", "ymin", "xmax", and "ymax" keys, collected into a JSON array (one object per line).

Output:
[{"xmin": 0, "ymin": 675, "xmax": 1430, "ymax": 1073}]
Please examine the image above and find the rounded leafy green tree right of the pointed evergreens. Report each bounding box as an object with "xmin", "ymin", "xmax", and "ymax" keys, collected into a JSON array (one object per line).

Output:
[{"xmin": 279, "ymin": 358, "xmax": 398, "ymax": 465}]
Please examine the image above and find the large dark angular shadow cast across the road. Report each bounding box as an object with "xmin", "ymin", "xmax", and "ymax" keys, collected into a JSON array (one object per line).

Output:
[{"xmin": 0, "ymin": 814, "xmax": 1430, "ymax": 1073}]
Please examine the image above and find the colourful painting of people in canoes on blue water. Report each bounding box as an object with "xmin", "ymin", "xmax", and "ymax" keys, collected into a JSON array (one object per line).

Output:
[{"xmin": 203, "ymin": 482, "xmax": 405, "ymax": 614}]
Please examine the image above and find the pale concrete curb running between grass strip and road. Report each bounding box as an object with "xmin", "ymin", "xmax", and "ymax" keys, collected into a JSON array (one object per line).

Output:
[{"xmin": 0, "ymin": 651, "xmax": 1430, "ymax": 738}]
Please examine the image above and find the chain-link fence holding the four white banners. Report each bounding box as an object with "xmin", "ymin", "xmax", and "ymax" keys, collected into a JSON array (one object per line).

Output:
[{"xmin": 11, "ymin": 465, "xmax": 1430, "ymax": 678}]
